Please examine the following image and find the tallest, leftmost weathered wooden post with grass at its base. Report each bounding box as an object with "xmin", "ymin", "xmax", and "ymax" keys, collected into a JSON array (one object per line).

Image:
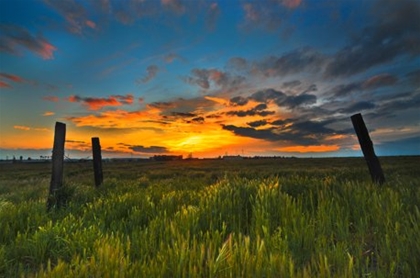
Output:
[{"xmin": 47, "ymin": 122, "xmax": 66, "ymax": 210}]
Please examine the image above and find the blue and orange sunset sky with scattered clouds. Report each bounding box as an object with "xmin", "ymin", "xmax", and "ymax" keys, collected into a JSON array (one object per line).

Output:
[{"xmin": 0, "ymin": 0, "xmax": 420, "ymax": 159}]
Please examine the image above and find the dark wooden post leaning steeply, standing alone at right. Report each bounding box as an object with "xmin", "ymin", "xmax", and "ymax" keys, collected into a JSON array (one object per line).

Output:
[{"xmin": 351, "ymin": 113, "xmax": 385, "ymax": 185}]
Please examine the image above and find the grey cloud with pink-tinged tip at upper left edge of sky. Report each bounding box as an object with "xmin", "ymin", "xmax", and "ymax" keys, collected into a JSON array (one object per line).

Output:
[{"xmin": 0, "ymin": 24, "xmax": 57, "ymax": 60}]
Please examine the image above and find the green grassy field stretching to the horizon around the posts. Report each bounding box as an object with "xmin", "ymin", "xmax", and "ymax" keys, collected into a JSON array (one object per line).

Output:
[{"xmin": 0, "ymin": 157, "xmax": 420, "ymax": 277}]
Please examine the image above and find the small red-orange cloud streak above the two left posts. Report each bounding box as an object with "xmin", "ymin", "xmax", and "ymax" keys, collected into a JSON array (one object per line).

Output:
[{"xmin": 67, "ymin": 94, "xmax": 134, "ymax": 110}]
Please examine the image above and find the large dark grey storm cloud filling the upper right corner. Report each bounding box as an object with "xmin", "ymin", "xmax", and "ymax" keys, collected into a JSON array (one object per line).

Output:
[{"xmin": 325, "ymin": 0, "xmax": 420, "ymax": 77}]
